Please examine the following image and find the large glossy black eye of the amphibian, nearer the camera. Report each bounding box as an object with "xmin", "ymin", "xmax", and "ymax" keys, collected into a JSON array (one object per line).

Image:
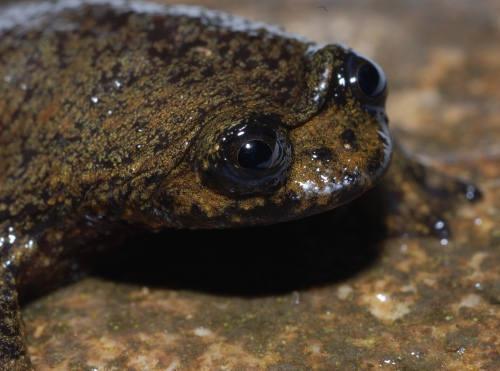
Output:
[{"xmin": 203, "ymin": 116, "xmax": 292, "ymax": 197}]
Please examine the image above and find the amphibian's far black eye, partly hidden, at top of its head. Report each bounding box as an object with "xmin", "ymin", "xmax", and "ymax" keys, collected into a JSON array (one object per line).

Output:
[{"xmin": 349, "ymin": 55, "xmax": 387, "ymax": 103}]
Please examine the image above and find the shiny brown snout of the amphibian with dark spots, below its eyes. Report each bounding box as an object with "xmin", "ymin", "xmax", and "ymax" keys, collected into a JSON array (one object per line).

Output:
[{"xmin": 287, "ymin": 119, "xmax": 392, "ymax": 210}]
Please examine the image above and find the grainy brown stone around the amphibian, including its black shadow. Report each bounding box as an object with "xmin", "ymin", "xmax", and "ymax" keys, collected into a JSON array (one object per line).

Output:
[{"xmin": 23, "ymin": 0, "xmax": 500, "ymax": 370}]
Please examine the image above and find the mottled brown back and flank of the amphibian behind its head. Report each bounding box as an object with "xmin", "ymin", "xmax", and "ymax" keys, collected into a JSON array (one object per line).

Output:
[{"xmin": 0, "ymin": 1, "xmax": 307, "ymax": 228}]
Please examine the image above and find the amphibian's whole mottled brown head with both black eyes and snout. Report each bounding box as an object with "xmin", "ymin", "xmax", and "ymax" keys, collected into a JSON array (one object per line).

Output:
[{"xmin": 145, "ymin": 45, "xmax": 392, "ymax": 227}]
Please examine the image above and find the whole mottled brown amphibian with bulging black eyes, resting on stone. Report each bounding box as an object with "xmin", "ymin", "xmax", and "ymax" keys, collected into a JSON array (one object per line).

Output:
[{"xmin": 0, "ymin": 0, "xmax": 480, "ymax": 370}]
